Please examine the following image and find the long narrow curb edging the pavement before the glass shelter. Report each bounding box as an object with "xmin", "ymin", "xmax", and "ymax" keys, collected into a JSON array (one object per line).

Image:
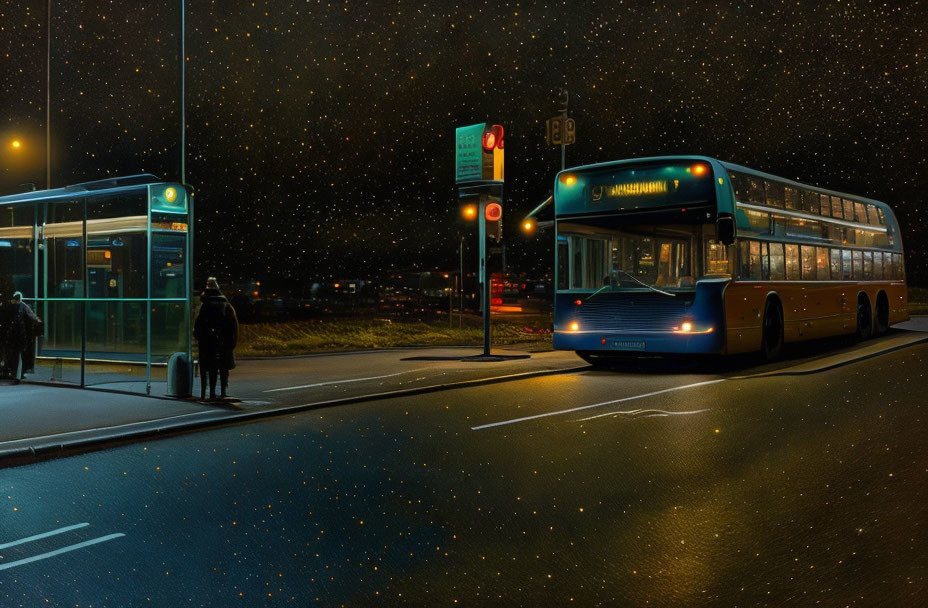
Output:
[{"xmin": 0, "ymin": 365, "xmax": 591, "ymax": 469}]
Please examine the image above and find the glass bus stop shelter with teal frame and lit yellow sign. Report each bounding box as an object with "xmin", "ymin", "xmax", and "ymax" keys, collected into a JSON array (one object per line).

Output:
[{"xmin": 0, "ymin": 174, "xmax": 193, "ymax": 396}]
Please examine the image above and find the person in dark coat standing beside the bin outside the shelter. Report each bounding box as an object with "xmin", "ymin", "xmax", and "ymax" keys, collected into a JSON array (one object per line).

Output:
[{"xmin": 193, "ymin": 277, "xmax": 238, "ymax": 399}]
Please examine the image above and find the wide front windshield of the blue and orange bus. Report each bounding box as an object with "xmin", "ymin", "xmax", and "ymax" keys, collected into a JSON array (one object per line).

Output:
[{"xmin": 557, "ymin": 218, "xmax": 731, "ymax": 290}]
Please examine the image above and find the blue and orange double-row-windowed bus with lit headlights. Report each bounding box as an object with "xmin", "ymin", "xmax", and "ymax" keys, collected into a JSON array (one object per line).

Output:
[{"xmin": 553, "ymin": 156, "xmax": 909, "ymax": 365}]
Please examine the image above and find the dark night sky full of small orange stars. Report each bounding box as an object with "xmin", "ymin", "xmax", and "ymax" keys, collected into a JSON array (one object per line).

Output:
[{"xmin": 0, "ymin": 0, "xmax": 928, "ymax": 284}]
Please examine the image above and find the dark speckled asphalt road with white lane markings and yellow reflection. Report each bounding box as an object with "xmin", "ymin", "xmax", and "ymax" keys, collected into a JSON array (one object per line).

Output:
[{"xmin": 0, "ymin": 334, "xmax": 928, "ymax": 606}]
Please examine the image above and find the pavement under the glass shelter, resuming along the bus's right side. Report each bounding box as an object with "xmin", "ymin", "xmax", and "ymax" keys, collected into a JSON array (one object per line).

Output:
[{"xmin": 0, "ymin": 317, "xmax": 928, "ymax": 467}]
